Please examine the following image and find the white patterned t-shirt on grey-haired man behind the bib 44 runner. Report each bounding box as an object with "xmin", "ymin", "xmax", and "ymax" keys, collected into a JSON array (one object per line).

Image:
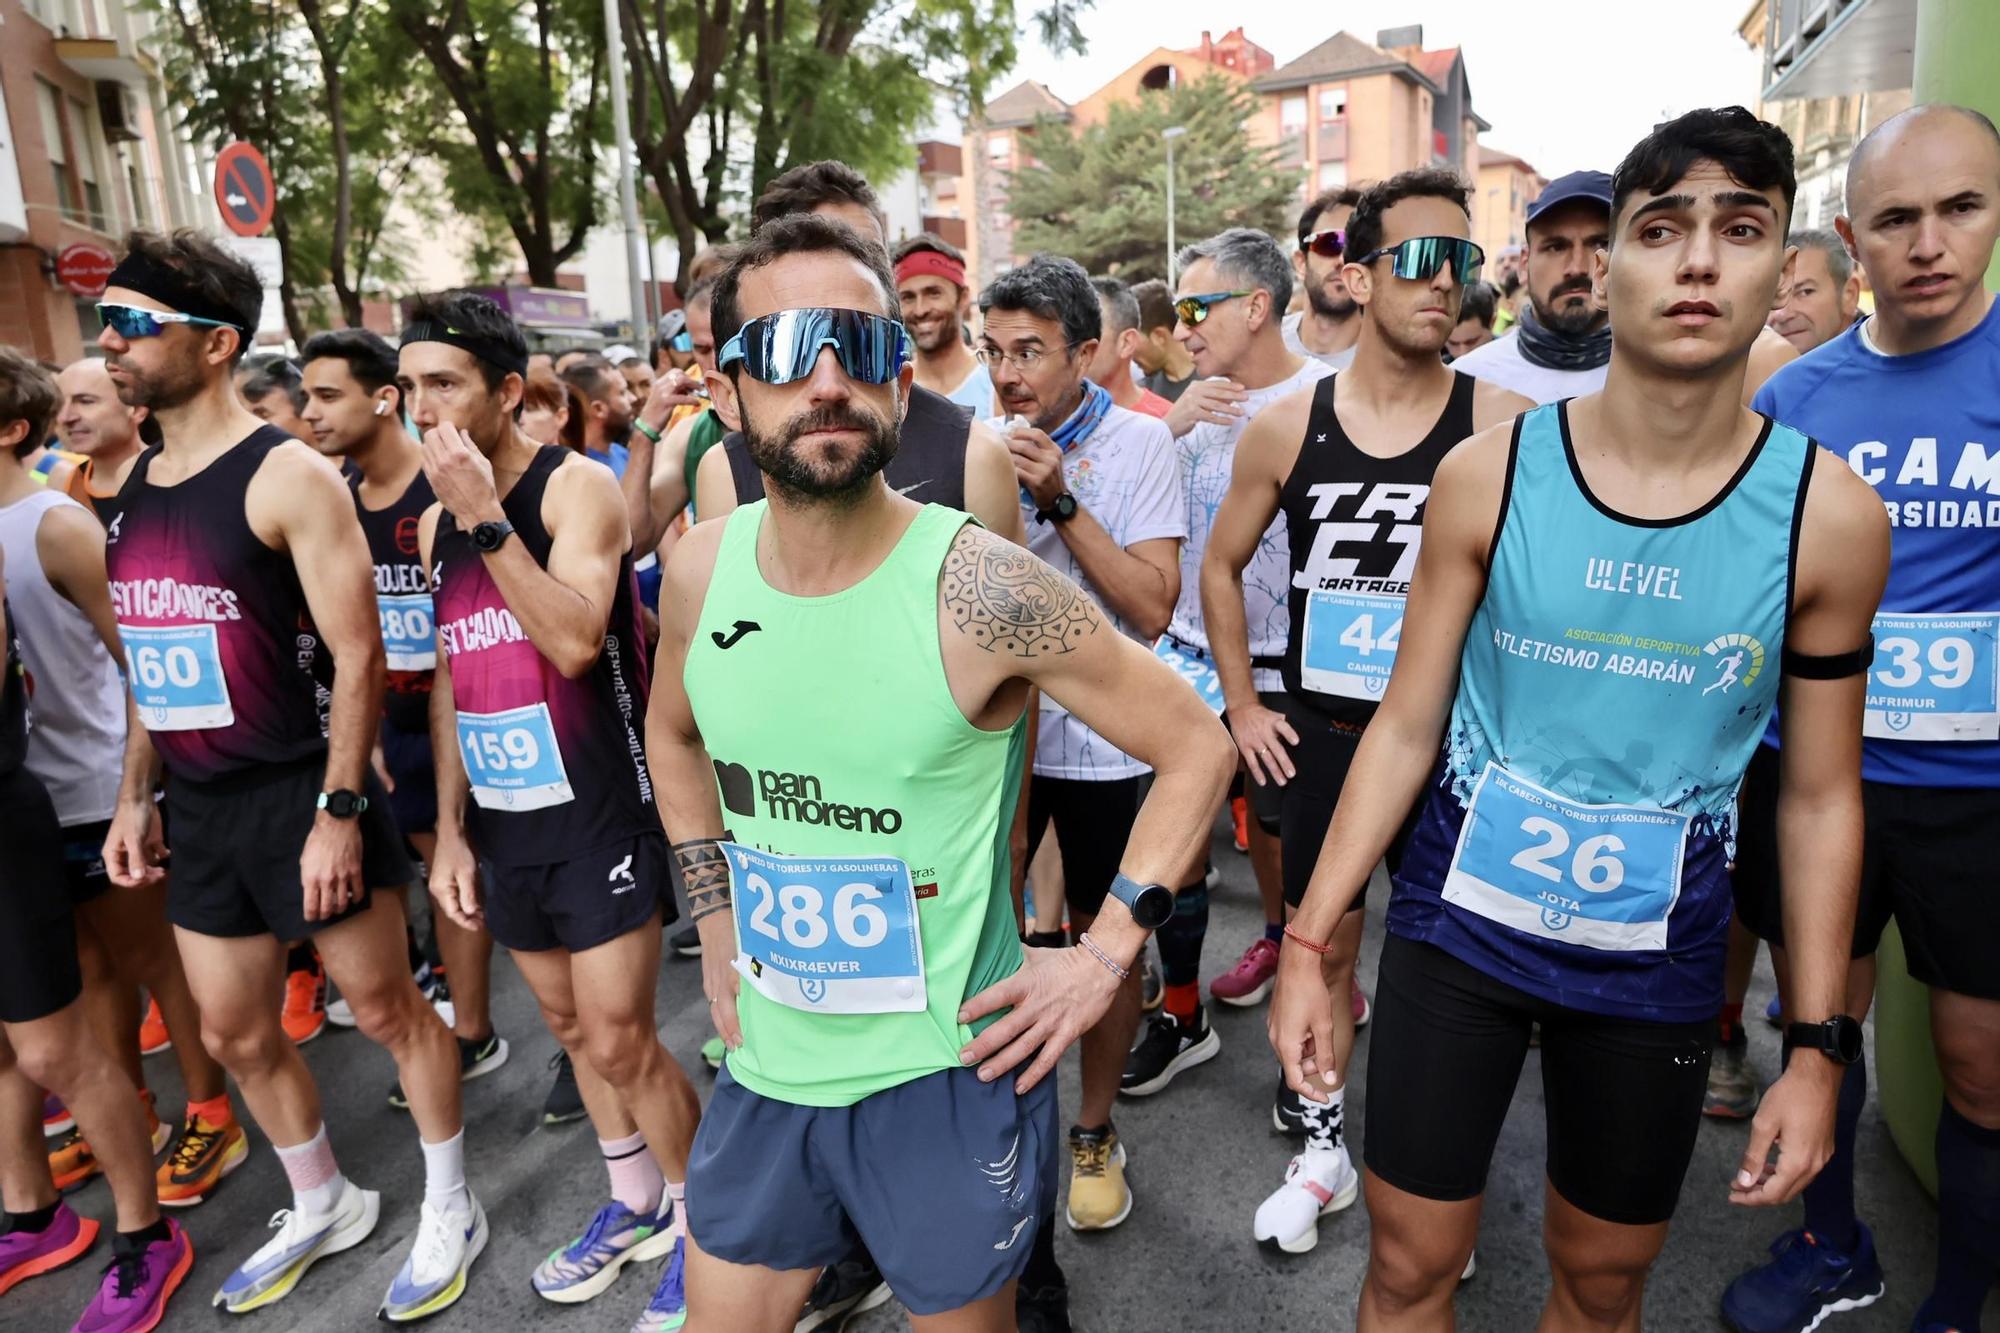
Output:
[{"xmin": 1168, "ymin": 356, "xmax": 1334, "ymax": 693}]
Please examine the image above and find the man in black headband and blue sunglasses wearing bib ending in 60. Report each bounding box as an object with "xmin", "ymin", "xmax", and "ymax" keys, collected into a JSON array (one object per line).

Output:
[{"xmin": 98, "ymin": 223, "xmax": 486, "ymax": 1319}]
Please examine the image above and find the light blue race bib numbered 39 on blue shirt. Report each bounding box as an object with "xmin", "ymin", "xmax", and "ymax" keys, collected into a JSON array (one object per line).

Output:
[{"xmin": 1862, "ymin": 612, "xmax": 2000, "ymax": 741}]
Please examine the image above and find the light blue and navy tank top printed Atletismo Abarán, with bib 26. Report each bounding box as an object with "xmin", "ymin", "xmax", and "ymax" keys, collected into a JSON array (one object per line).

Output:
[{"xmin": 1388, "ymin": 402, "xmax": 1814, "ymax": 1023}]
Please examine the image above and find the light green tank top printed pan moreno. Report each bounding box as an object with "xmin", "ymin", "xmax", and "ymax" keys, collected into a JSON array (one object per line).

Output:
[{"xmin": 682, "ymin": 500, "xmax": 1026, "ymax": 1107}]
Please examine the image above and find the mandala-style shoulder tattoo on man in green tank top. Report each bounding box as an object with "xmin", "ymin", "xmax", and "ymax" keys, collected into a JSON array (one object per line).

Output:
[{"xmin": 944, "ymin": 534, "xmax": 1098, "ymax": 656}]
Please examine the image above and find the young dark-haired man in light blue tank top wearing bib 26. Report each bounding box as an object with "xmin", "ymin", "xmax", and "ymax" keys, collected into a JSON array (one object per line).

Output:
[{"xmin": 1270, "ymin": 106, "xmax": 1888, "ymax": 1331}]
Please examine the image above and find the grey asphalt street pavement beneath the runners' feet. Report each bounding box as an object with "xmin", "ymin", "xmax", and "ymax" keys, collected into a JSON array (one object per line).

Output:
[{"xmin": 0, "ymin": 820, "xmax": 2000, "ymax": 1333}]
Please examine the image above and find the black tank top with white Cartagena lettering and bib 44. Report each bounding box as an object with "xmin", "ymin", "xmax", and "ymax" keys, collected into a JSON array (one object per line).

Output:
[{"xmin": 1278, "ymin": 372, "xmax": 1476, "ymax": 727}]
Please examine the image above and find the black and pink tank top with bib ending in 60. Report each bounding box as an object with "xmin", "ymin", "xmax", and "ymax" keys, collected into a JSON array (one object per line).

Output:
[{"xmin": 104, "ymin": 426, "xmax": 326, "ymax": 781}]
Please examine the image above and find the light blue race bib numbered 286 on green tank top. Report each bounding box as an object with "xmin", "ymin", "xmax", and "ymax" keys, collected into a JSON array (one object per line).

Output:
[{"xmin": 722, "ymin": 843, "xmax": 930, "ymax": 1013}]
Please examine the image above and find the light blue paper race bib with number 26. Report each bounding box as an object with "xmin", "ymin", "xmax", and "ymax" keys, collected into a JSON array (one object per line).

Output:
[{"xmin": 1444, "ymin": 763, "xmax": 1690, "ymax": 951}]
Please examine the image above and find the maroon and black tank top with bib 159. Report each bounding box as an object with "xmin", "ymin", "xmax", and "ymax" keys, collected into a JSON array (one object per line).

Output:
[{"xmin": 430, "ymin": 444, "xmax": 660, "ymax": 865}]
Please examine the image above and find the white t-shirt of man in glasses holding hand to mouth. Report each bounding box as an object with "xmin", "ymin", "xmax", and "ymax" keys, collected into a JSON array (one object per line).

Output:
[{"xmin": 1016, "ymin": 404, "xmax": 1188, "ymax": 783}]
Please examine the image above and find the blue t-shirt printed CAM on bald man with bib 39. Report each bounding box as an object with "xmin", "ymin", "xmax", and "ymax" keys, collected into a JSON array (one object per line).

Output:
[{"xmin": 1756, "ymin": 302, "xmax": 2000, "ymax": 787}]
